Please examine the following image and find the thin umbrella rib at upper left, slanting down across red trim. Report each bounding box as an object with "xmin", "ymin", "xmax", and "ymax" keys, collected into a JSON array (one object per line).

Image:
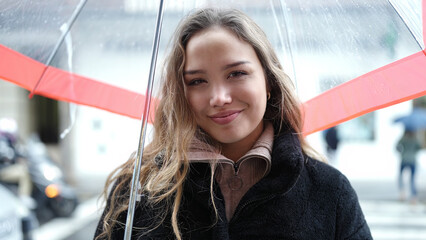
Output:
[{"xmin": 29, "ymin": 0, "xmax": 87, "ymax": 98}]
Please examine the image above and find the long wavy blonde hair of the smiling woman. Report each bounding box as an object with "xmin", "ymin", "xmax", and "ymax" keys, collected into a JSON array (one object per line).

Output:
[{"xmin": 97, "ymin": 8, "xmax": 320, "ymax": 239}]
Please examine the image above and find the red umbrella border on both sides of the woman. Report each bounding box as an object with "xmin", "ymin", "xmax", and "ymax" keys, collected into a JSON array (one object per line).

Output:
[{"xmin": 0, "ymin": 0, "xmax": 426, "ymax": 135}]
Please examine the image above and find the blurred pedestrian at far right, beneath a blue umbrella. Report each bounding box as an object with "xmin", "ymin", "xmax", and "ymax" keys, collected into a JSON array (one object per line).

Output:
[{"xmin": 396, "ymin": 129, "xmax": 421, "ymax": 203}]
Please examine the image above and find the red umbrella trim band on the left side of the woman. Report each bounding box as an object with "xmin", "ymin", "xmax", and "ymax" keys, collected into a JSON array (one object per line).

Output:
[{"xmin": 0, "ymin": 45, "xmax": 156, "ymax": 123}]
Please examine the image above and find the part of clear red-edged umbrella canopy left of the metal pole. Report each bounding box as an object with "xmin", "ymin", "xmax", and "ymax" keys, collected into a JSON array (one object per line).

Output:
[{"xmin": 0, "ymin": 0, "xmax": 156, "ymax": 118}]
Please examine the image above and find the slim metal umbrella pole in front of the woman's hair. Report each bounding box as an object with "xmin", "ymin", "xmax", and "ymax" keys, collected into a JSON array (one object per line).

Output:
[{"xmin": 124, "ymin": 0, "xmax": 163, "ymax": 240}]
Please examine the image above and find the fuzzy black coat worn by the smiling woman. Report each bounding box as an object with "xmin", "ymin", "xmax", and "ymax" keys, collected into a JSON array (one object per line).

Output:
[{"xmin": 95, "ymin": 134, "xmax": 372, "ymax": 240}]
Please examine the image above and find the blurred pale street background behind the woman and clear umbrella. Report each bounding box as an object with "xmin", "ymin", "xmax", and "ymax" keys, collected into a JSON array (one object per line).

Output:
[{"xmin": 0, "ymin": 0, "xmax": 426, "ymax": 240}]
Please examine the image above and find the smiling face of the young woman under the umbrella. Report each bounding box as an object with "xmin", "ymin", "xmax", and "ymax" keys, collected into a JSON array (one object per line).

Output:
[{"xmin": 184, "ymin": 27, "xmax": 267, "ymax": 158}]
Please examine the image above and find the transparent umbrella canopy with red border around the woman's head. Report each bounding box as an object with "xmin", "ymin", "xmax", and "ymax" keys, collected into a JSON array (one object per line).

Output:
[{"xmin": 0, "ymin": 0, "xmax": 426, "ymax": 237}]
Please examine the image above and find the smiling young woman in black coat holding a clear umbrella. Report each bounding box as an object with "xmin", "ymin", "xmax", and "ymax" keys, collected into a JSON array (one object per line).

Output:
[{"xmin": 95, "ymin": 9, "xmax": 371, "ymax": 240}]
